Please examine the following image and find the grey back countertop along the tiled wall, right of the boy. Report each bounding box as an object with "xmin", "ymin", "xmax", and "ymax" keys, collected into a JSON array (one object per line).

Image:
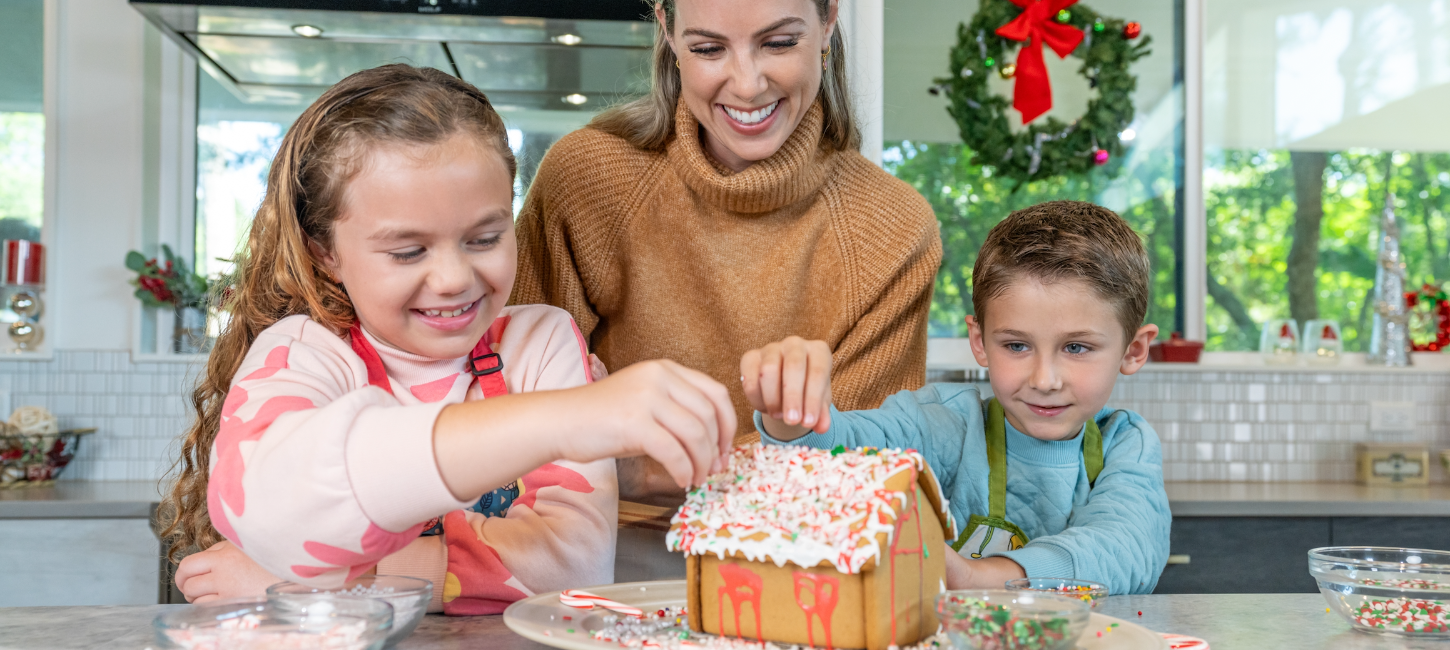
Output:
[{"xmin": 1164, "ymin": 483, "xmax": 1450, "ymax": 517}]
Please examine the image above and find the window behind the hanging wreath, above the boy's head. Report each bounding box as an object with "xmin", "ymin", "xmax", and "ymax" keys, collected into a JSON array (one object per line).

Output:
[{"xmin": 883, "ymin": 0, "xmax": 1183, "ymax": 337}]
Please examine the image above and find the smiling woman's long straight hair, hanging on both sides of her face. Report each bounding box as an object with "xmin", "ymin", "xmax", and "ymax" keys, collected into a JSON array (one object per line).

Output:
[{"xmin": 589, "ymin": 0, "xmax": 861, "ymax": 151}]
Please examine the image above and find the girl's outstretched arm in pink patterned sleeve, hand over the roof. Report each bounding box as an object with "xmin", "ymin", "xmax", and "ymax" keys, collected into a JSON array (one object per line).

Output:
[{"xmin": 207, "ymin": 316, "xmax": 735, "ymax": 586}]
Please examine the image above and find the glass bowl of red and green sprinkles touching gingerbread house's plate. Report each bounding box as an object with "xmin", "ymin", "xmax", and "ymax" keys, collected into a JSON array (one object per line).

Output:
[{"xmin": 937, "ymin": 589, "xmax": 1092, "ymax": 650}]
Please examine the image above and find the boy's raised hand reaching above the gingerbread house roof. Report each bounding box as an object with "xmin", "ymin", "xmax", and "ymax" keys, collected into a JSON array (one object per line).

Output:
[{"xmin": 740, "ymin": 337, "xmax": 831, "ymax": 441}]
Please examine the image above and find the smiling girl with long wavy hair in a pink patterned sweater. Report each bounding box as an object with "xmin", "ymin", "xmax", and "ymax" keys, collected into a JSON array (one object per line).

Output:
[{"xmin": 167, "ymin": 65, "xmax": 735, "ymax": 614}]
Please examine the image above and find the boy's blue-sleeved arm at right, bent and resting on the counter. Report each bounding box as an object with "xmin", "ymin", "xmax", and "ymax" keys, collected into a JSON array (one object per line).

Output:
[{"xmin": 999, "ymin": 411, "xmax": 1173, "ymax": 593}]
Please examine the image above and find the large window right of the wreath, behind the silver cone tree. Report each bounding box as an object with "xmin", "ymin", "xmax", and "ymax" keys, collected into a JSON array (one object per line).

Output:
[{"xmin": 1204, "ymin": 0, "xmax": 1450, "ymax": 351}]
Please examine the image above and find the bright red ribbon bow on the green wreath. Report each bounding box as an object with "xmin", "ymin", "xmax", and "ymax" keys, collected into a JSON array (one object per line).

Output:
[{"xmin": 996, "ymin": 0, "xmax": 1083, "ymax": 125}]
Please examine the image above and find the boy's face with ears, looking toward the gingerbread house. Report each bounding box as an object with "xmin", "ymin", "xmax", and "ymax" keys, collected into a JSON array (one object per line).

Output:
[{"xmin": 967, "ymin": 279, "xmax": 1159, "ymax": 440}]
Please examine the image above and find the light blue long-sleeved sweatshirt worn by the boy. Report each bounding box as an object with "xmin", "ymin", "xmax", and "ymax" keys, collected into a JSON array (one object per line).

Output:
[{"xmin": 755, "ymin": 383, "xmax": 1173, "ymax": 593}]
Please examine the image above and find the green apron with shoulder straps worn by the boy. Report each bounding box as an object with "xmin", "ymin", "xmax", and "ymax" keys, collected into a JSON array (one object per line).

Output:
[{"xmin": 951, "ymin": 398, "xmax": 1102, "ymax": 559}]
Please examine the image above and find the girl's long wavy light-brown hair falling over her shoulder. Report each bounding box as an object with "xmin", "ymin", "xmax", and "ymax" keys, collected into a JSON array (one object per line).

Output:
[{"xmin": 162, "ymin": 64, "xmax": 516, "ymax": 560}]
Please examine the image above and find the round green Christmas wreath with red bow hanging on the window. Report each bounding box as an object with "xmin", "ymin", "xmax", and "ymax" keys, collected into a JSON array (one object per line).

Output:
[{"xmin": 932, "ymin": 0, "xmax": 1151, "ymax": 187}]
